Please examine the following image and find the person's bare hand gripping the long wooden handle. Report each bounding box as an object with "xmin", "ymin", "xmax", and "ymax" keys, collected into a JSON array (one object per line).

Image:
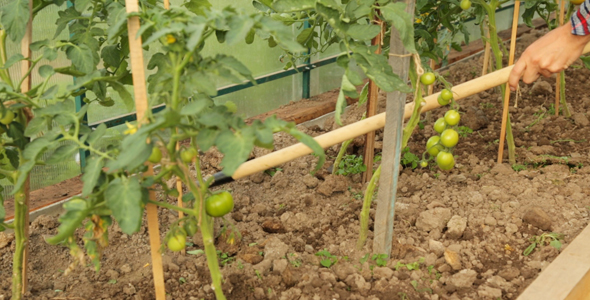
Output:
[{"xmin": 508, "ymin": 22, "xmax": 590, "ymax": 91}]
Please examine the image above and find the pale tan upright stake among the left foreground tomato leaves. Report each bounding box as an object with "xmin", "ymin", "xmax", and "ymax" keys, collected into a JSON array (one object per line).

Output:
[{"xmin": 125, "ymin": 0, "xmax": 166, "ymax": 300}]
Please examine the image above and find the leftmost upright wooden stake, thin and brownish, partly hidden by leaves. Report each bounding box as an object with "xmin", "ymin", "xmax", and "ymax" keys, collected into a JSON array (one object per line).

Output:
[{"xmin": 20, "ymin": 0, "xmax": 33, "ymax": 294}]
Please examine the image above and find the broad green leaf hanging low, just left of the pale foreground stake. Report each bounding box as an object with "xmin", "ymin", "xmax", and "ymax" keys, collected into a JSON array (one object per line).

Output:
[{"xmin": 104, "ymin": 177, "xmax": 145, "ymax": 234}]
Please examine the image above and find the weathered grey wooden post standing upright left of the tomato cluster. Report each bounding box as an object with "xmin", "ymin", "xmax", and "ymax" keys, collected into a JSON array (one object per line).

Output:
[{"xmin": 373, "ymin": 0, "xmax": 416, "ymax": 257}]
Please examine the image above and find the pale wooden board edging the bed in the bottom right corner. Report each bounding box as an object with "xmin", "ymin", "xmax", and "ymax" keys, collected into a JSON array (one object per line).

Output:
[{"xmin": 517, "ymin": 225, "xmax": 590, "ymax": 300}]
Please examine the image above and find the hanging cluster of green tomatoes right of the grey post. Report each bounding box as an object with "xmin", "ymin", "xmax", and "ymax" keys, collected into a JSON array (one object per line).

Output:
[{"xmin": 420, "ymin": 72, "xmax": 461, "ymax": 171}]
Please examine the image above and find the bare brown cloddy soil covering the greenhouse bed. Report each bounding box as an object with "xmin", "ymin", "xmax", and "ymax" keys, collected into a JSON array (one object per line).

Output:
[{"xmin": 0, "ymin": 31, "xmax": 590, "ymax": 300}]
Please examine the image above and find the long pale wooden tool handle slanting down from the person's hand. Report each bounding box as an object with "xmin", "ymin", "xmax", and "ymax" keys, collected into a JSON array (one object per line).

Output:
[{"xmin": 230, "ymin": 44, "xmax": 590, "ymax": 179}]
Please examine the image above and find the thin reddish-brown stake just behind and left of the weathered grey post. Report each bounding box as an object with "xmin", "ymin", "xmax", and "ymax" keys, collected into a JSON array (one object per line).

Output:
[{"xmin": 362, "ymin": 17, "xmax": 384, "ymax": 183}]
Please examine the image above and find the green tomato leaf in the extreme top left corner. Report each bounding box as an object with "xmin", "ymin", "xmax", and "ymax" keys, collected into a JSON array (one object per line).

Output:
[{"xmin": 0, "ymin": 0, "xmax": 29, "ymax": 42}]
